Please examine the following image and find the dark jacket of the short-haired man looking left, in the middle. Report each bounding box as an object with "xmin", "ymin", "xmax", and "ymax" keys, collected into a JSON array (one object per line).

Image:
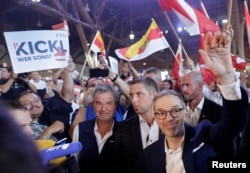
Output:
[{"xmin": 112, "ymin": 115, "xmax": 144, "ymax": 173}]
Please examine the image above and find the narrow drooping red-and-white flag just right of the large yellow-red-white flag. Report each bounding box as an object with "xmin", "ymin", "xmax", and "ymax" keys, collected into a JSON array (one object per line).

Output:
[{"xmin": 172, "ymin": 43, "xmax": 183, "ymax": 79}]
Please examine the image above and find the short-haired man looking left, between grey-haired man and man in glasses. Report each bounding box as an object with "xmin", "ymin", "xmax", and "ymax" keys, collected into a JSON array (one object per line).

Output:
[{"xmin": 112, "ymin": 77, "xmax": 159, "ymax": 173}]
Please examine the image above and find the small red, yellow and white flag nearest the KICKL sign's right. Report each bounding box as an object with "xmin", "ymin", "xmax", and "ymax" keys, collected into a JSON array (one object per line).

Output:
[{"xmin": 89, "ymin": 30, "xmax": 106, "ymax": 57}]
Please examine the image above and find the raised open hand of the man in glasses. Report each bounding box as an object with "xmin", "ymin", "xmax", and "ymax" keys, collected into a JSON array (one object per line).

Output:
[{"xmin": 199, "ymin": 26, "xmax": 235, "ymax": 84}]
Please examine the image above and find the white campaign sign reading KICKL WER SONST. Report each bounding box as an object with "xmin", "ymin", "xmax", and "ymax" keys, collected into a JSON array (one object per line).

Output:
[{"xmin": 4, "ymin": 30, "xmax": 69, "ymax": 73}]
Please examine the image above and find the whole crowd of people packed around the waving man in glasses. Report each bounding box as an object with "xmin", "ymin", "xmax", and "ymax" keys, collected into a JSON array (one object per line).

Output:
[{"xmin": 0, "ymin": 26, "xmax": 250, "ymax": 173}]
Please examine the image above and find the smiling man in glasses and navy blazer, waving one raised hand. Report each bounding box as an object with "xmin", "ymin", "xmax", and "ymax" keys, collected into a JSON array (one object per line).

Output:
[{"xmin": 144, "ymin": 26, "xmax": 248, "ymax": 173}]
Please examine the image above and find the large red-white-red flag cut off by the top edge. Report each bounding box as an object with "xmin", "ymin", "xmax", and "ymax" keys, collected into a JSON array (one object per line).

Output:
[{"xmin": 159, "ymin": 0, "xmax": 220, "ymax": 36}]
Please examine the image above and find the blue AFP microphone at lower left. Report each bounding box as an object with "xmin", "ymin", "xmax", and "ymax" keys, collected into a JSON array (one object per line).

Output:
[{"xmin": 40, "ymin": 142, "xmax": 82, "ymax": 164}]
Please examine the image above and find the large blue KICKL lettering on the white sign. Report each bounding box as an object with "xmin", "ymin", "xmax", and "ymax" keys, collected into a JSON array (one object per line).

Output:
[{"xmin": 13, "ymin": 40, "xmax": 68, "ymax": 61}]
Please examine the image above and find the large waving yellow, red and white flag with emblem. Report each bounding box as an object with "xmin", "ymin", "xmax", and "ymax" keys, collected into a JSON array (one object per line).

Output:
[{"xmin": 115, "ymin": 19, "xmax": 169, "ymax": 61}]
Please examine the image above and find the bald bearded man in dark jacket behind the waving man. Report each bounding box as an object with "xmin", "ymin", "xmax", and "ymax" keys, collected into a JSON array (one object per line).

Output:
[{"xmin": 181, "ymin": 71, "xmax": 239, "ymax": 158}]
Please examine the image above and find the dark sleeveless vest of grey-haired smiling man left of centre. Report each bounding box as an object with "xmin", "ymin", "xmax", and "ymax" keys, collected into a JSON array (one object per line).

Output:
[{"xmin": 79, "ymin": 119, "xmax": 117, "ymax": 173}]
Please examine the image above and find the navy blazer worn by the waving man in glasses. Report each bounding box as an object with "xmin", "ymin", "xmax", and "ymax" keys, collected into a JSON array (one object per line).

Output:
[{"xmin": 144, "ymin": 88, "xmax": 248, "ymax": 173}]
